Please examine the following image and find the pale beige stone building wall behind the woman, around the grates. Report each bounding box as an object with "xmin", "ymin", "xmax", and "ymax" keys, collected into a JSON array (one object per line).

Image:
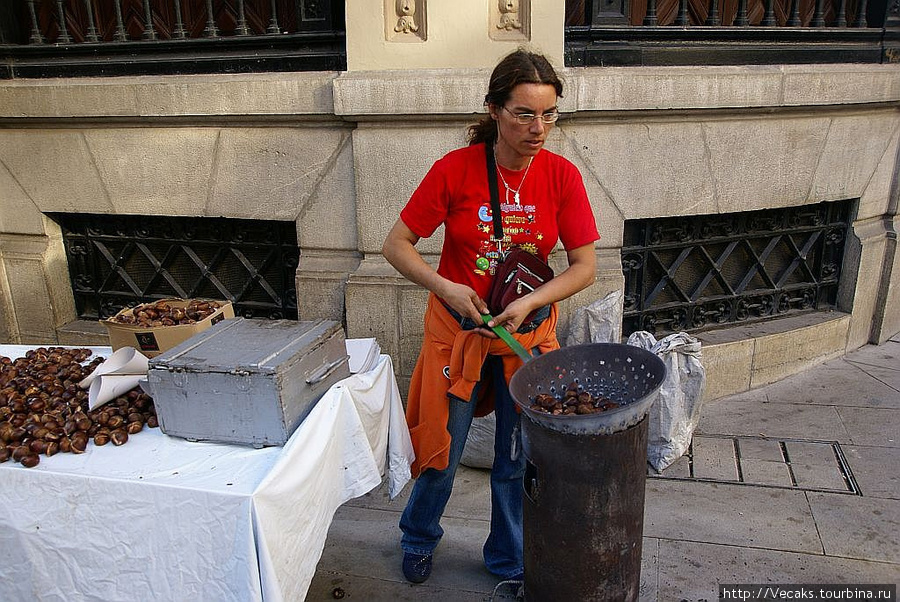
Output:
[{"xmin": 0, "ymin": 0, "xmax": 900, "ymax": 399}]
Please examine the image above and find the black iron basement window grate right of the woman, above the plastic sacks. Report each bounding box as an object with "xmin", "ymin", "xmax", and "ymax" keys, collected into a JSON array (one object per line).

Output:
[{"xmin": 622, "ymin": 200, "xmax": 854, "ymax": 336}]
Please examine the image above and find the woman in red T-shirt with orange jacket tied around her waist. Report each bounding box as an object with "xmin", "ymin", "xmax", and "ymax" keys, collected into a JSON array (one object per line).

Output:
[{"xmin": 382, "ymin": 50, "xmax": 599, "ymax": 583}]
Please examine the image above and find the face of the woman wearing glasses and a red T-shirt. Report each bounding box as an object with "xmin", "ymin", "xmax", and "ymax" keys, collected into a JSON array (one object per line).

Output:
[{"xmin": 489, "ymin": 84, "xmax": 557, "ymax": 169}]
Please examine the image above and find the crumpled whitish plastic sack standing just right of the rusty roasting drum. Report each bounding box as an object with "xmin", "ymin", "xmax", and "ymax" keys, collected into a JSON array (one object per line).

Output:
[{"xmin": 628, "ymin": 331, "xmax": 706, "ymax": 472}]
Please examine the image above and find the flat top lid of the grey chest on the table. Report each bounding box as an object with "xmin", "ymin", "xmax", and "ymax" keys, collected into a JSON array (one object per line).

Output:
[{"xmin": 150, "ymin": 318, "xmax": 341, "ymax": 373}]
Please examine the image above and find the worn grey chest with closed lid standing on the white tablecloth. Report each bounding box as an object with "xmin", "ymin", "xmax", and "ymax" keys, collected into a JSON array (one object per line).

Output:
[{"xmin": 148, "ymin": 318, "xmax": 350, "ymax": 447}]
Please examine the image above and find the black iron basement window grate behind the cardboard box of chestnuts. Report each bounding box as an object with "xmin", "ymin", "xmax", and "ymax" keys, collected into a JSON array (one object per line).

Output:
[{"xmin": 48, "ymin": 213, "xmax": 300, "ymax": 320}]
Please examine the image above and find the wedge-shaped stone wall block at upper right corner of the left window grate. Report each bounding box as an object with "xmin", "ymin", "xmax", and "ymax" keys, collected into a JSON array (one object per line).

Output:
[{"xmin": 297, "ymin": 133, "xmax": 359, "ymax": 253}]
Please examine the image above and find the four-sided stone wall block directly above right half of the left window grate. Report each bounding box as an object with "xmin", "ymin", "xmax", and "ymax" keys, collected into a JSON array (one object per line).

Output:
[{"xmin": 213, "ymin": 127, "xmax": 352, "ymax": 223}]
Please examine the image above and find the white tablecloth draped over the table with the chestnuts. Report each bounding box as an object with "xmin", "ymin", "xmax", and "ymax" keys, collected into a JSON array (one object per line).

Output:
[{"xmin": 0, "ymin": 346, "xmax": 412, "ymax": 602}]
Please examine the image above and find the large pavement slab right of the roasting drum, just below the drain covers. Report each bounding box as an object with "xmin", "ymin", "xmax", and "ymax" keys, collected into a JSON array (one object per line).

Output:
[{"xmin": 644, "ymin": 479, "xmax": 822, "ymax": 554}]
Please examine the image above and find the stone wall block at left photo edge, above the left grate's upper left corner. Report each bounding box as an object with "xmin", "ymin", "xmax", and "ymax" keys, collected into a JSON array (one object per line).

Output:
[{"xmin": 0, "ymin": 129, "xmax": 110, "ymax": 214}]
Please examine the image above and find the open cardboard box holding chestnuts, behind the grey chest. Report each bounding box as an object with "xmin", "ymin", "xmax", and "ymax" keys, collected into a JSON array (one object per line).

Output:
[{"xmin": 100, "ymin": 299, "xmax": 234, "ymax": 357}]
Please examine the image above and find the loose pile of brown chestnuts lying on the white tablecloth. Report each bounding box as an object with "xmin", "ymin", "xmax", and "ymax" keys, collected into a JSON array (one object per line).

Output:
[{"xmin": 0, "ymin": 347, "xmax": 159, "ymax": 468}]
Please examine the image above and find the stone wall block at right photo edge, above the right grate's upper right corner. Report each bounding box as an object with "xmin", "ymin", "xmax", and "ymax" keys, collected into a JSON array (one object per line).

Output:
[{"xmin": 808, "ymin": 111, "xmax": 898, "ymax": 207}]
